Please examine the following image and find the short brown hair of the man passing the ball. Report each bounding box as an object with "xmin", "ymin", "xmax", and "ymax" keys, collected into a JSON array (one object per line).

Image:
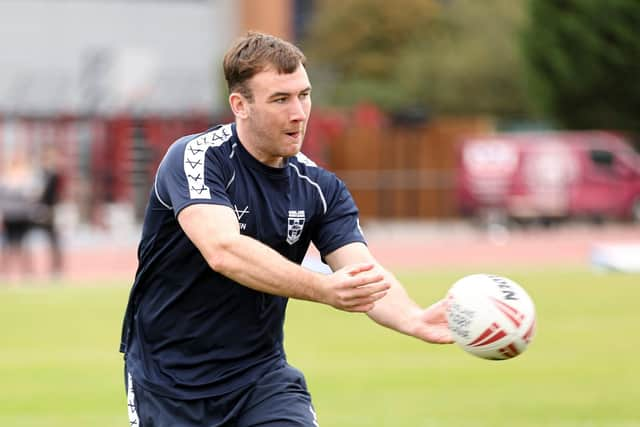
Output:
[{"xmin": 223, "ymin": 31, "xmax": 307, "ymax": 101}]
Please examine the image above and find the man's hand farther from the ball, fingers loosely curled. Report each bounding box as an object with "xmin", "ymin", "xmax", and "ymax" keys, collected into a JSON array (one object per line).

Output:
[{"xmin": 320, "ymin": 263, "xmax": 391, "ymax": 313}]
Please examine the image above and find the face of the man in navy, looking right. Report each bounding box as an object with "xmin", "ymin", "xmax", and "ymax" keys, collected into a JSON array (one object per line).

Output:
[{"xmin": 246, "ymin": 65, "xmax": 311, "ymax": 166}]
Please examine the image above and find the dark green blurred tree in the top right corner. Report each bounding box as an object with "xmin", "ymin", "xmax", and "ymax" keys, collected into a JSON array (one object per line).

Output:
[{"xmin": 522, "ymin": 0, "xmax": 640, "ymax": 132}]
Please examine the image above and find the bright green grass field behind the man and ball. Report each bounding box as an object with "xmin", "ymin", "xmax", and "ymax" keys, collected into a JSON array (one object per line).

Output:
[{"xmin": 0, "ymin": 269, "xmax": 640, "ymax": 427}]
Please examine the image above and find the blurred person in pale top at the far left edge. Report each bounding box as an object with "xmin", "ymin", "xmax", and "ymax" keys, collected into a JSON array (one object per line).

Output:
[{"xmin": 0, "ymin": 148, "xmax": 42, "ymax": 275}]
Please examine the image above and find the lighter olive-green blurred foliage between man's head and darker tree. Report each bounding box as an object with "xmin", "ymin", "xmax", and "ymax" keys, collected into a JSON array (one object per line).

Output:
[{"xmin": 305, "ymin": 0, "xmax": 526, "ymax": 116}]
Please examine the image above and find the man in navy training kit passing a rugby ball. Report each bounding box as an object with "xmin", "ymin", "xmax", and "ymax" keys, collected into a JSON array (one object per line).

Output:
[{"xmin": 121, "ymin": 33, "xmax": 451, "ymax": 427}]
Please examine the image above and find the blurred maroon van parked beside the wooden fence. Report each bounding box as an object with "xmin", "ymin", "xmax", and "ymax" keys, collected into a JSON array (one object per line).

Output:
[{"xmin": 456, "ymin": 131, "xmax": 640, "ymax": 221}]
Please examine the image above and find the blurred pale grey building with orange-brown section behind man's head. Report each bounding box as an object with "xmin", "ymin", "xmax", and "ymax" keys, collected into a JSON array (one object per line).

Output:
[{"xmin": 0, "ymin": 0, "xmax": 310, "ymax": 116}]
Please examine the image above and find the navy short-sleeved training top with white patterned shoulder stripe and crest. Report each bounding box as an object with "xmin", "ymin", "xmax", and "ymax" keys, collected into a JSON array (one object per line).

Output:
[{"xmin": 120, "ymin": 124, "xmax": 365, "ymax": 399}]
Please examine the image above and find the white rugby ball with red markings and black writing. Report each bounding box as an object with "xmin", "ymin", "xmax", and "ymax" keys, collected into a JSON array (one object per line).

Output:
[{"xmin": 447, "ymin": 274, "xmax": 536, "ymax": 360}]
